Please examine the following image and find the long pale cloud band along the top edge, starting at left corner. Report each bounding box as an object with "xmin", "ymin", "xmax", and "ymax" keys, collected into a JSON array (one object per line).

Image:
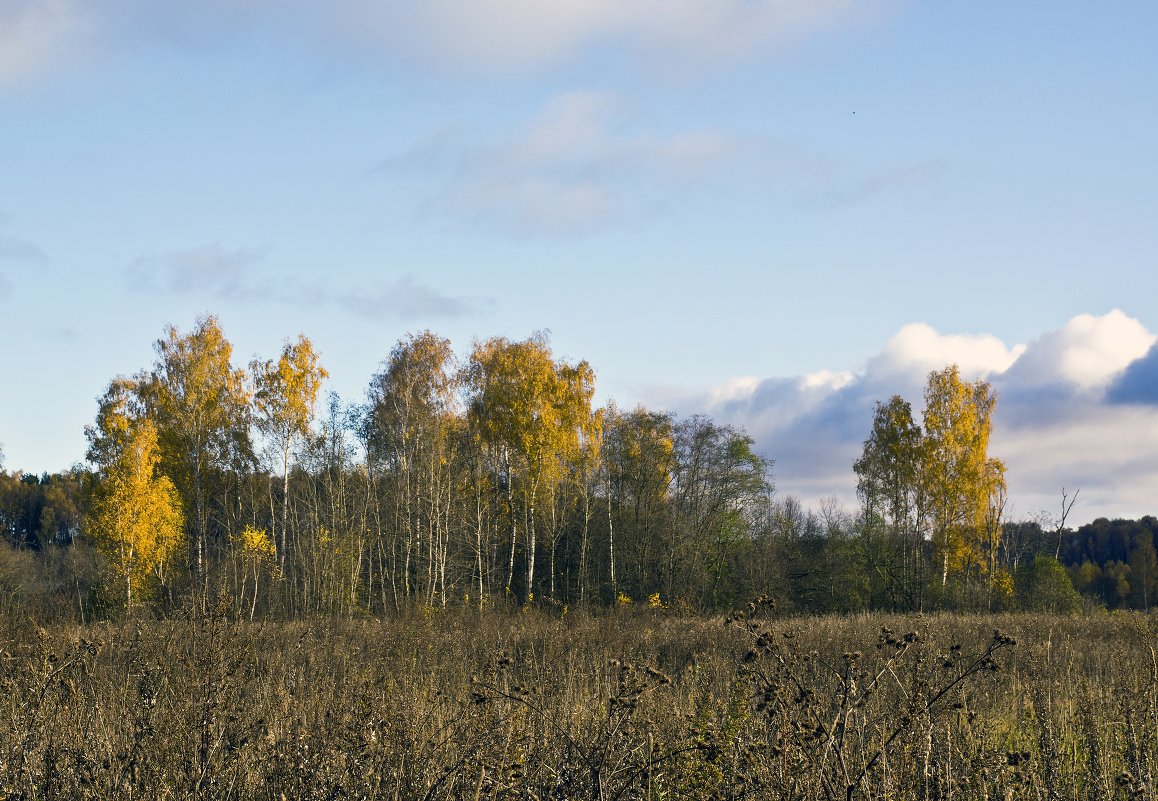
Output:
[{"xmin": 0, "ymin": 0, "xmax": 895, "ymax": 84}]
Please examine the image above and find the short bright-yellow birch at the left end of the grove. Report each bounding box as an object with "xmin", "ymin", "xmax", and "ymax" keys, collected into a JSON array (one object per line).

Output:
[{"xmin": 87, "ymin": 419, "xmax": 183, "ymax": 607}]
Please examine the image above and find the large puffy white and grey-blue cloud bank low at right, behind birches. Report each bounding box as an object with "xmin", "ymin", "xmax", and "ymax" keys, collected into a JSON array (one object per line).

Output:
[{"xmin": 677, "ymin": 309, "xmax": 1158, "ymax": 523}]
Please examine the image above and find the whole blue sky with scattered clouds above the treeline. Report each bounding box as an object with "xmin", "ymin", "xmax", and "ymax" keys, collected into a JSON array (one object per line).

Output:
[{"xmin": 0, "ymin": 0, "xmax": 1158, "ymax": 522}]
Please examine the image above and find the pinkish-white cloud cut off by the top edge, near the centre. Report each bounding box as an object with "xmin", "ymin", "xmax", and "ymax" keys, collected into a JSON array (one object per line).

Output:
[{"xmin": 337, "ymin": 0, "xmax": 870, "ymax": 71}]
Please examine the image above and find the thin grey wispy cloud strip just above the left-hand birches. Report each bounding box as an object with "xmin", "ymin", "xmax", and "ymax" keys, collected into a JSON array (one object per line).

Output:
[{"xmin": 125, "ymin": 244, "xmax": 483, "ymax": 321}]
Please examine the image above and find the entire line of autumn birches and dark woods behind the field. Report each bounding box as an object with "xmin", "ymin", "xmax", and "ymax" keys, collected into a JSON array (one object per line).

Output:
[{"xmin": 0, "ymin": 316, "xmax": 1158, "ymax": 620}]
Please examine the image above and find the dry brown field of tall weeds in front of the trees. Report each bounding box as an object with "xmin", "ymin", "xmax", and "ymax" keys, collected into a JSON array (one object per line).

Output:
[{"xmin": 0, "ymin": 602, "xmax": 1158, "ymax": 801}]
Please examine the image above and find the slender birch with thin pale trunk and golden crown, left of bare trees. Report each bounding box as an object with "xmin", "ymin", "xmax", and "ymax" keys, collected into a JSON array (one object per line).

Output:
[{"xmin": 250, "ymin": 336, "xmax": 329, "ymax": 569}]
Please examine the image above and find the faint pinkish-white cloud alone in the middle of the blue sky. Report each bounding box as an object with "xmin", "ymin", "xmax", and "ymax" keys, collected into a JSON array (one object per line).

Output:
[{"xmin": 402, "ymin": 91, "xmax": 742, "ymax": 235}]
